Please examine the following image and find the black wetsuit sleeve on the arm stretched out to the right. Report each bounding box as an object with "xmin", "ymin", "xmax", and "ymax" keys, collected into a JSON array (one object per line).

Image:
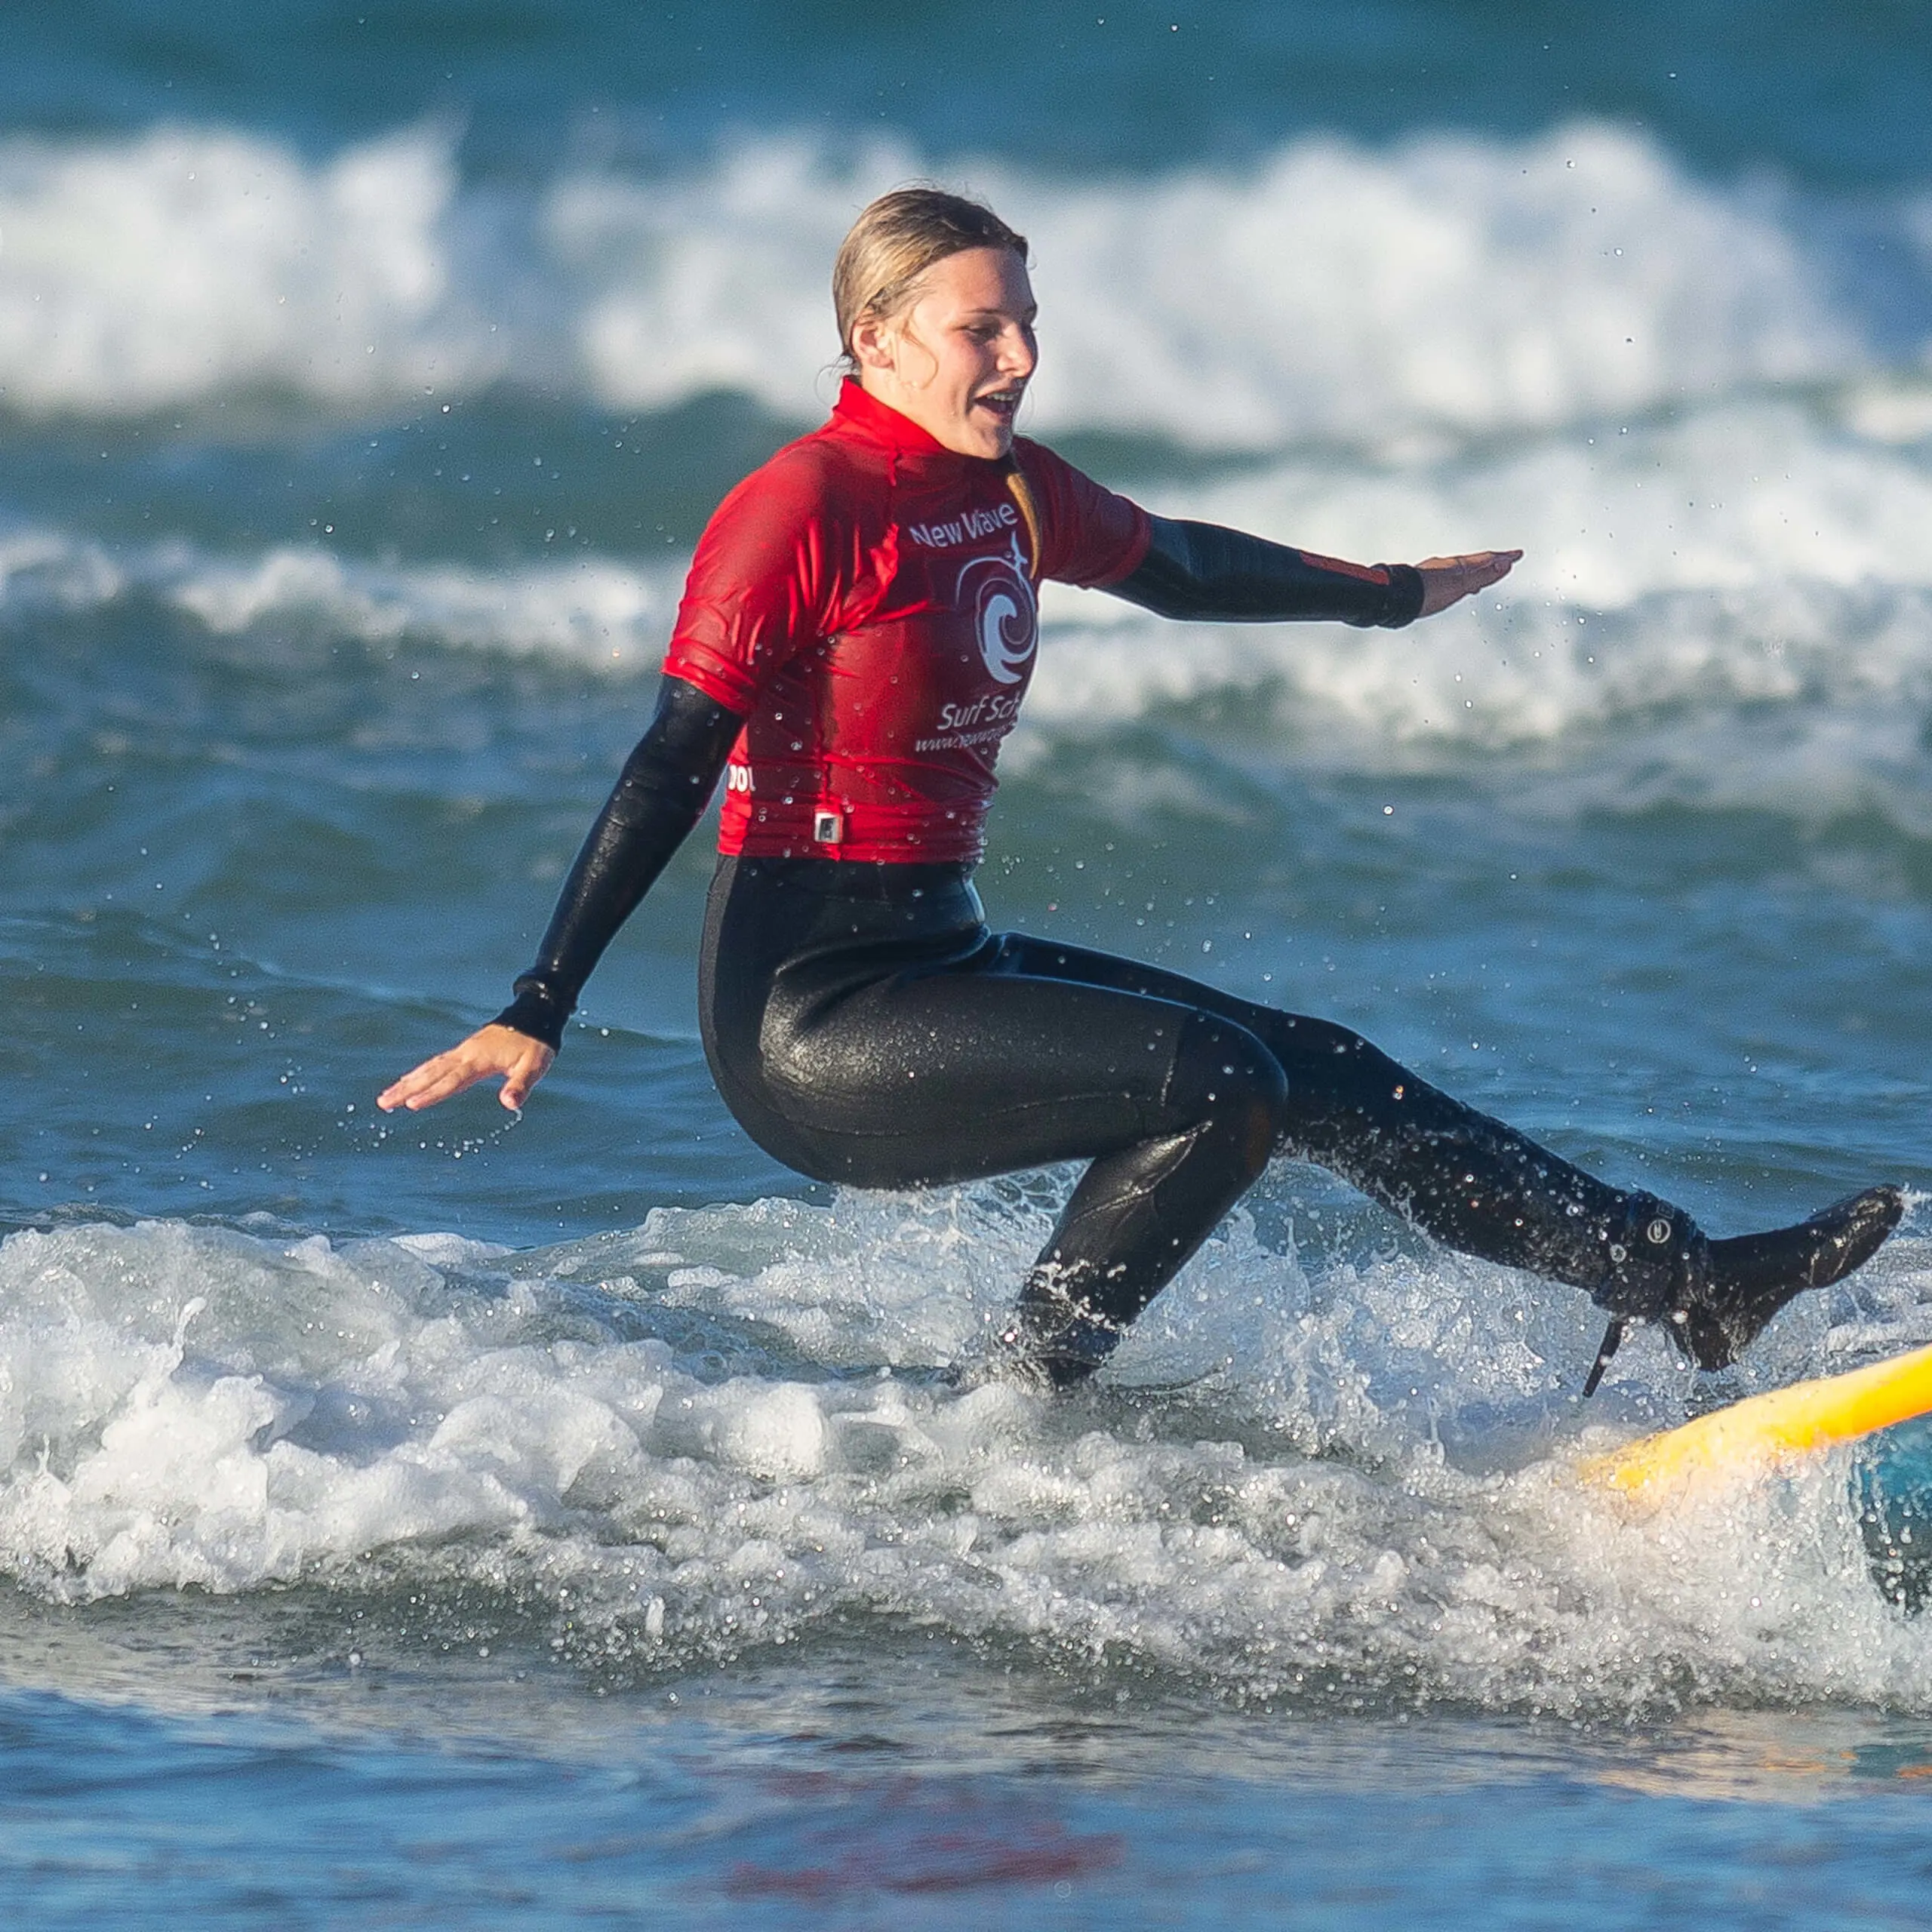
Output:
[{"xmin": 1105, "ymin": 516, "xmax": 1422, "ymax": 630}]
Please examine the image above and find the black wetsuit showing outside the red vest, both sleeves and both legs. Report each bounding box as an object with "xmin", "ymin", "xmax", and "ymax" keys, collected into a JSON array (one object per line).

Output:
[{"xmin": 478, "ymin": 520, "xmax": 1897, "ymax": 1383}]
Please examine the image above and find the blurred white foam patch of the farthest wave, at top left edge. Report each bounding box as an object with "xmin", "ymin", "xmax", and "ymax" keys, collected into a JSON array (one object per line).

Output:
[{"xmin": 0, "ymin": 128, "xmax": 506, "ymax": 415}]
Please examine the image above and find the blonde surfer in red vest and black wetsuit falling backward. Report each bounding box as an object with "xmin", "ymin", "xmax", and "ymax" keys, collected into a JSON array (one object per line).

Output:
[{"xmin": 379, "ymin": 187, "xmax": 1903, "ymax": 1393}]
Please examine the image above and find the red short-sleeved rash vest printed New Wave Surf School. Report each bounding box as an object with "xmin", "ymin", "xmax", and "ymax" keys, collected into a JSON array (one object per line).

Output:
[{"xmin": 665, "ymin": 380, "xmax": 1149, "ymax": 863}]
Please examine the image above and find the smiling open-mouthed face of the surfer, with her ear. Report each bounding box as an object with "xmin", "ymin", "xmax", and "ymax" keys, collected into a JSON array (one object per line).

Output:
[{"xmin": 852, "ymin": 248, "xmax": 1039, "ymax": 456}]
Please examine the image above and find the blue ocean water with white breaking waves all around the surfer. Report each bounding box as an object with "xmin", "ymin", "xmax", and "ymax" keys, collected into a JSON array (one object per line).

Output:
[{"xmin": 11, "ymin": 0, "xmax": 1932, "ymax": 1928}]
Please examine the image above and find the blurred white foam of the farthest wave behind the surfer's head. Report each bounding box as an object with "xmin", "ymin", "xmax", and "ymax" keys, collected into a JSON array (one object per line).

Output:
[{"xmin": 546, "ymin": 125, "xmax": 1869, "ymax": 448}]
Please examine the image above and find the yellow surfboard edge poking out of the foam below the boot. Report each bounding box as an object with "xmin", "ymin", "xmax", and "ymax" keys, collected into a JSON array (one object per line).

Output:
[{"xmin": 1579, "ymin": 1346, "xmax": 1932, "ymax": 1507}]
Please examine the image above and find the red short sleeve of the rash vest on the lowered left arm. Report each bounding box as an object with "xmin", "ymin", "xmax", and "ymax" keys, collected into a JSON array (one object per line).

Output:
[{"xmin": 665, "ymin": 442, "xmax": 852, "ymax": 717}]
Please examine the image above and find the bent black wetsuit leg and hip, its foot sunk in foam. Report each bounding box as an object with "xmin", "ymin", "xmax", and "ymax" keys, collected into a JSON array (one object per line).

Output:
[{"xmin": 701, "ymin": 867, "xmax": 1289, "ymax": 1380}]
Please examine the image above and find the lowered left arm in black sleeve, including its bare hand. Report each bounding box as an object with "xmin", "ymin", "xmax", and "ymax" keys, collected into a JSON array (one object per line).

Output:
[{"xmin": 377, "ymin": 676, "xmax": 744, "ymax": 1113}]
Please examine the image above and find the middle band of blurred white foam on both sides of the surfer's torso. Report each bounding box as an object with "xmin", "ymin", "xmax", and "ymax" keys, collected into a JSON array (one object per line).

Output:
[{"xmin": 11, "ymin": 355, "xmax": 1932, "ymax": 808}]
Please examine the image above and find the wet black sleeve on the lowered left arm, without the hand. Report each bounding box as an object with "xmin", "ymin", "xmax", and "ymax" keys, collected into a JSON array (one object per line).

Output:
[{"xmin": 497, "ymin": 678, "xmax": 744, "ymax": 1049}]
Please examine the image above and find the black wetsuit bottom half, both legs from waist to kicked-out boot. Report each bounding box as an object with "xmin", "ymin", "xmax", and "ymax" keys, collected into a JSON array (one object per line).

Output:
[{"xmin": 700, "ymin": 862, "xmax": 1901, "ymax": 1381}]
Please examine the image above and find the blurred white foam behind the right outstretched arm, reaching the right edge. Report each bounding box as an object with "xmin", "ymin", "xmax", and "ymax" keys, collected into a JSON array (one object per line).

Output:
[{"xmin": 1014, "ymin": 400, "xmax": 1932, "ymax": 799}]
